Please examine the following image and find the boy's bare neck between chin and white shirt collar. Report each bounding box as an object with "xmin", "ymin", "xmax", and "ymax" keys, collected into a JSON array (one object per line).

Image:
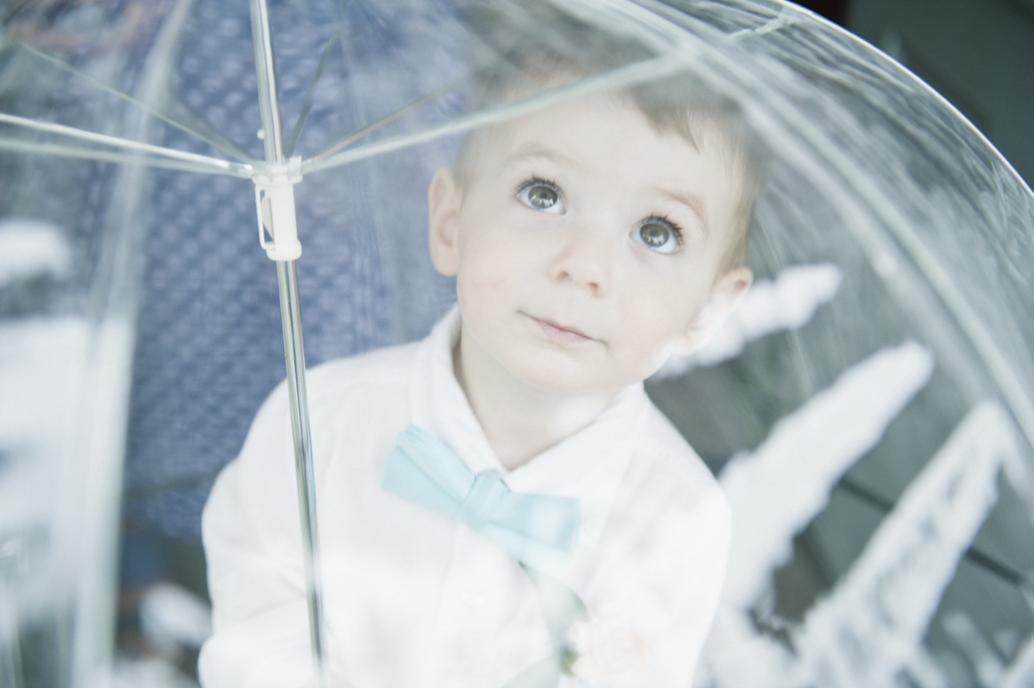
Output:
[{"xmin": 453, "ymin": 336, "xmax": 617, "ymax": 471}]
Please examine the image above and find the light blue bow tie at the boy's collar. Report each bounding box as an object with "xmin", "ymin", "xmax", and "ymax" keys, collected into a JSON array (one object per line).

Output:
[{"xmin": 384, "ymin": 425, "xmax": 579, "ymax": 562}]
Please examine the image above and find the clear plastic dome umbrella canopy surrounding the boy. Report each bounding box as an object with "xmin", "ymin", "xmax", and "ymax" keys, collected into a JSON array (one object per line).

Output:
[{"xmin": 0, "ymin": 0, "xmax": 1034, "ymax": 686}]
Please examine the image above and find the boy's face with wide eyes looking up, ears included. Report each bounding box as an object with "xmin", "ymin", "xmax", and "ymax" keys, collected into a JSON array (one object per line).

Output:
[{"xmin": 429, "ymin": 95, "xmax": 751, "ymax": 393}]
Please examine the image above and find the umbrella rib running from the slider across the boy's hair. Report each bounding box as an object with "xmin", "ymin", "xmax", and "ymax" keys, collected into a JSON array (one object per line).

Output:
[{"xmin": 302, "ymin": 55, "xmax": 683, "ymax": 174}]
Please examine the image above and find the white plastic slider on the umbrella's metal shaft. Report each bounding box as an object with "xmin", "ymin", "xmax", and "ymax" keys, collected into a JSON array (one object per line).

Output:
[{"xmin": 251, "ymin": 156, "xmax": 302, "ymax": 261}]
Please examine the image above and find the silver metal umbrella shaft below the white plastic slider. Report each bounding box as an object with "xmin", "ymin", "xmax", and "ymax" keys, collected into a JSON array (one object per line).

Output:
[{"xmin": 276, "ymin": 261, "xmax": 324, "ymax": 679}]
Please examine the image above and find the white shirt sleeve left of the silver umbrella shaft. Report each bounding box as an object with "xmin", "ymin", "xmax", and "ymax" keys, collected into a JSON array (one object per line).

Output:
[{"xmin": 199, "ymin": 386, "xmax": 337, "ymax": 688}]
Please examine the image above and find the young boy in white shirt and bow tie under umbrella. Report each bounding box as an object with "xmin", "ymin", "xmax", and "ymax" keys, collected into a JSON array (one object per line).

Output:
[{"xmin": 201, "ymin": 40, "xmax": 755, "ymax": 688}]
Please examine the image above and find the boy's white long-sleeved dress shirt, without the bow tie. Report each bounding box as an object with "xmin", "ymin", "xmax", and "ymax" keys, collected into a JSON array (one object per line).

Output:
[{"xmin": 200, "ymin": 308, "xmax": 729, "ymax": 688}]
